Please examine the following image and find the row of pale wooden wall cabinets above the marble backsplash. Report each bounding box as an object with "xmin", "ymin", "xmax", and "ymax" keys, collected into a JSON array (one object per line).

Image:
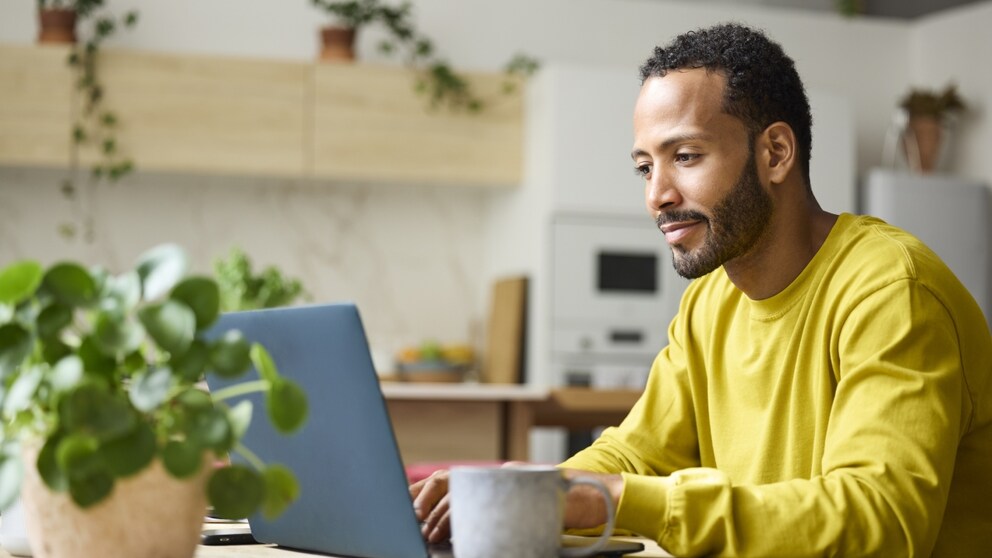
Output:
[{"xmin": 0, "ymin": 45, "xmax": 523, "ymax": 186}]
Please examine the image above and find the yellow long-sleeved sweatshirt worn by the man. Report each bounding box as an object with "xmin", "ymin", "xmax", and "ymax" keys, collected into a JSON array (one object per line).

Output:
[{"xmin": 562, "ymin": 214, "xmax": 992, "ymax": 557}]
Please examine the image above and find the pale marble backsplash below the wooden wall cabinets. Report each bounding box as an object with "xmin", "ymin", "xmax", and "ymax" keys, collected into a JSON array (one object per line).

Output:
[{"xmin": 0, "ymin": 168, "xmax": 489, "ymax": 374}]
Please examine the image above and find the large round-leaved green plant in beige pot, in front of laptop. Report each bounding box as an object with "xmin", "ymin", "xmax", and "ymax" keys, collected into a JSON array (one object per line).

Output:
[{"xmin": 0, "ymin": 245, "xmax": 306, "ymax": 557}]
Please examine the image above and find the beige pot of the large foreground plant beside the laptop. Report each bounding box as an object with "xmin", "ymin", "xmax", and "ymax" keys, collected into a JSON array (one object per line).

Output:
[{"xmin": 21, "ymin": 446, "xmax": 211, "ymax": 558}]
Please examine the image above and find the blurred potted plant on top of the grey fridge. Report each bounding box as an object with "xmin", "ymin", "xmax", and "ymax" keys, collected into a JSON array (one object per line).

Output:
[{"xmin": 899, "ymin": 84, "xmax": 966, "ymax": 173}]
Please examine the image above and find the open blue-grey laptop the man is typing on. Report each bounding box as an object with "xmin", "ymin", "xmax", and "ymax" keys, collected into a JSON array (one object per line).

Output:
[{"xmin": 207, "ymin": 303, "xmax": 643, "ymax": 558}]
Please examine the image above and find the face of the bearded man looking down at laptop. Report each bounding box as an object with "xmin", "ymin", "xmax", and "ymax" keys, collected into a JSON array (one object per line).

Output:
[{"xmin": 631, "ymin": 69, "xmax": 773, "ymax": 279}]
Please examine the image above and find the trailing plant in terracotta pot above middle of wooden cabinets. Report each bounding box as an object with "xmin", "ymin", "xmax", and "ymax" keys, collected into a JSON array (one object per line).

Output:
[{"xmin": 311, "ymin": 0, "xmax": 538, "ymax": 112}]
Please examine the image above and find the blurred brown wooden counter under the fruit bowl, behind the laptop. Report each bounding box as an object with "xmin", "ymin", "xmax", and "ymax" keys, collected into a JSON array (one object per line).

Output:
[{"xmin": 382, "ymin": 382, "xmax": 640, "ymax": 464}]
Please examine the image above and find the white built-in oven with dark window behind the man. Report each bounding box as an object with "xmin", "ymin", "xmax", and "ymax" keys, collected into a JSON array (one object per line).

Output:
[{"xmin": 551, "ymin": 214, "xmax": 688, "ymax": 388}]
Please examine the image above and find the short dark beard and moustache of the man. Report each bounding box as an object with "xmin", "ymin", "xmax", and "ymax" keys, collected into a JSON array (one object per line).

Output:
[{"xmin": 655, "ymin": 151, "xmax": 773, "ymax": 279}]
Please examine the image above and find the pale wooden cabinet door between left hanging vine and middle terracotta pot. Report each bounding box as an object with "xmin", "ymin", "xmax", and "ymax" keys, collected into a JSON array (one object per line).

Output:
[{"xmin": 87, "ymin": 50, "xmax": 309, "ymax": 176}]
